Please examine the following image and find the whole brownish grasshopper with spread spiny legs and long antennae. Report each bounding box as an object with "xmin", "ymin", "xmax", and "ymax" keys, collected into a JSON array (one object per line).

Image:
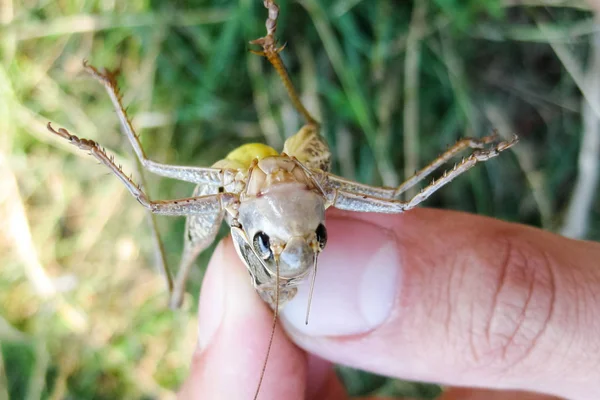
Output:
[{"xmin": 48, "ymin": 0, "xmax": 518, "ymax": 398}]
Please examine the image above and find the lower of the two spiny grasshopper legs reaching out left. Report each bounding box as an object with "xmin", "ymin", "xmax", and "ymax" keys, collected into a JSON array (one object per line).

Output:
[{"xmin": 48, "ymin": 124, "xmax": 237, "ymax": 216}]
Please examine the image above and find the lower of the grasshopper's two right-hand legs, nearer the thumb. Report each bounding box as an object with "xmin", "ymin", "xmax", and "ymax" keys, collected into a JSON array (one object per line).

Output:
[{"xmin": 325, "ymin": 137, "xmax": 518, "ymax": 213}]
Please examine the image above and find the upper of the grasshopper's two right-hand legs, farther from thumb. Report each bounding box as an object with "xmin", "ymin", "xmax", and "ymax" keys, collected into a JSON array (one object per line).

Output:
[{"xmin": 328, "ymin": 134, "xmax": 518, "ymax": 199}]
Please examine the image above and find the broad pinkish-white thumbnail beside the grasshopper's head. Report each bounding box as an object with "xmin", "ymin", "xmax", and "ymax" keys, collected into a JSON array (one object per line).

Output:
[{"xmin": 282, "ymin": 219, "xmax": 401, "ymax": 336}]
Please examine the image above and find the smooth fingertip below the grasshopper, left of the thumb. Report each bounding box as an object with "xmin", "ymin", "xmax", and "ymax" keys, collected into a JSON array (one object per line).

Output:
[{"xmin": 179, "ymin": 239, "xmax": 307, "ymax": 400}]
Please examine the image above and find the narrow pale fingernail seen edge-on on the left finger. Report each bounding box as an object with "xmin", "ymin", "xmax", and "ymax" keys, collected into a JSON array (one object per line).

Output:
[{"xmin": 198, "ymin": 242, "xmax": 225, "ymax": 351}]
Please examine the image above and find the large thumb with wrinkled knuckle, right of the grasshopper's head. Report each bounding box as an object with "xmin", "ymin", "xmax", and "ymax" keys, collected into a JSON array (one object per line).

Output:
[{"xmin": 283, "ymin": 209, "xmax": 600, "ymax": 398}]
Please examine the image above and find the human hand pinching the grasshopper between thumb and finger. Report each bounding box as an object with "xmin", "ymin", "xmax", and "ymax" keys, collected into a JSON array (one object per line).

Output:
[{"xmin": 180, "ymin": 209, "xmax": 600, "ymax": 400}]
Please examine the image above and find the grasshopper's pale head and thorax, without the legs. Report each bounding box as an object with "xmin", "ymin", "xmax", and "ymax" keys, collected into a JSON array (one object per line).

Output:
[{"xmin": 225, "ymin": 154, "xmax": 325, "ymax": 303}]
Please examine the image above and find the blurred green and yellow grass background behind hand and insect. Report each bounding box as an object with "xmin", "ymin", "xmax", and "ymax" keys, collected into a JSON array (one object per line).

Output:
[{"xmin": 0, "ymin": 0, "xmax": 600, "ymax": 400}]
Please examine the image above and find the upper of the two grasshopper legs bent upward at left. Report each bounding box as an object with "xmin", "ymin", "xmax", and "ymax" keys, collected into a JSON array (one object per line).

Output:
[{"xmin": 83, "ymin": 62, "xmax": 228, "ymax": 186}]
